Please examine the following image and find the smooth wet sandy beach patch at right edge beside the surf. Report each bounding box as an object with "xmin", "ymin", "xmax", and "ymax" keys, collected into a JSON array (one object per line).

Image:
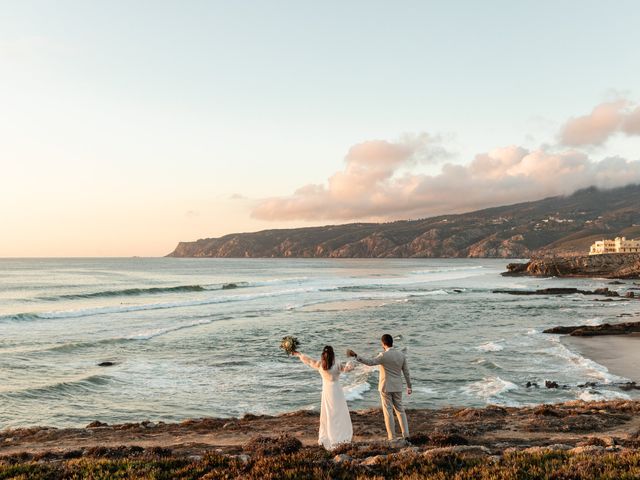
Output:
[{"xmin": 561, "ymin": 334, "xmax": 640, "ymax": 382}]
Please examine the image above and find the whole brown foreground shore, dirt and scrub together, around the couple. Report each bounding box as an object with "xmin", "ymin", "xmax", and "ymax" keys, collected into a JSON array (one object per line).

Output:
[{"xmin": 0, "ymin": 401, "xmax": 640, "ymax": 478}]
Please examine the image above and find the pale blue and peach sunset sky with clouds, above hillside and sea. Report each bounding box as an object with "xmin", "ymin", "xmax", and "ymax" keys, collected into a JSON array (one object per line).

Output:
[{"xmin": 0, "ymin": 0, "xmax": 640, "ymax": 257}]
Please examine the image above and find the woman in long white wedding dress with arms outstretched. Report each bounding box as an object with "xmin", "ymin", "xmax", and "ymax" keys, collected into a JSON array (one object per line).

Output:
[{"xmin": 294, "ymin": 345, "xmax": 353, "ymax": 450}]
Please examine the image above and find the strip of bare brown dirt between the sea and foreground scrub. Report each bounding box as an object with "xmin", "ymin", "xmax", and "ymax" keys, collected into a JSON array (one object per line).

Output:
[{"xmin": 0, "ymin": 401, "xmax": 640, "ymax": 457}]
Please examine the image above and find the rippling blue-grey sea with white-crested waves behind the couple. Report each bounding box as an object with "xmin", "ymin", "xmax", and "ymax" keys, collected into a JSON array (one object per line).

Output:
[{"xmin": 0, "ymin": 258, "xmax": 638, "ymax": 428}]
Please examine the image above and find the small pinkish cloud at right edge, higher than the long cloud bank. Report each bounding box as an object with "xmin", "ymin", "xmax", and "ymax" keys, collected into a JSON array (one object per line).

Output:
[{"xmin": 560, "ymin": 100, "xmax": 640, "ymax": 146}]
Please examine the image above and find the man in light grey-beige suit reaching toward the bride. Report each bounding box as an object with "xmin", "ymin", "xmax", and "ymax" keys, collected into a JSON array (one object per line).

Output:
[{"xmin": 347, "ymin": 334, "xmax": 411, "ymax": 440}]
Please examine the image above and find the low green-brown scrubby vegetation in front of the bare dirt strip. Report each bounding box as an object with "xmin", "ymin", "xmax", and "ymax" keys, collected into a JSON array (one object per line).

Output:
[{"xmin": 0, "ymin": 441, "xmax": 640, "ymax": 480}]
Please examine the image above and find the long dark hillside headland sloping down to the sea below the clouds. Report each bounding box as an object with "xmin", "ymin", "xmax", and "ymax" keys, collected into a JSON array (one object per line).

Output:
[{"xmin": 168, "ymin": 185, "xmax": 640, "ymax": 258}]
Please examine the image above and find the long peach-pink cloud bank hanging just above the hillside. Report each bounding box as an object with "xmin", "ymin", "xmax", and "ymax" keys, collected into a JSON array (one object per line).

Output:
[{"xmin": 252, "ymin": 140, "xmax": 640, "ymax": 221}]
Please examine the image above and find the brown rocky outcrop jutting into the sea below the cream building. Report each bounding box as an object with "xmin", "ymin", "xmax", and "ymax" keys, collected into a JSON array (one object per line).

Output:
[{"xmin": 503, "ymin": 253, "xmax": 640, "ymax": 278}]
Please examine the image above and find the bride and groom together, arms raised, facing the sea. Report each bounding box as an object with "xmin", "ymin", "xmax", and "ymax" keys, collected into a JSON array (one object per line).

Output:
[{"xmin": 293, "ymin": 334, "xmax": 411, "ymax": 450}]
